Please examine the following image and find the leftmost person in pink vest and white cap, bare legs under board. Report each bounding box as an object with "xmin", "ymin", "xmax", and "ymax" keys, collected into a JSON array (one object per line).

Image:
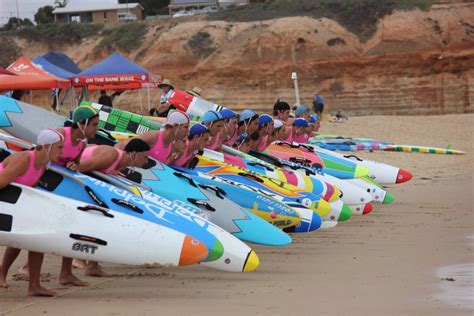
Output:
[{"xmin": 0, "ymin": 129, "xmax": 64, "ymax": 296}]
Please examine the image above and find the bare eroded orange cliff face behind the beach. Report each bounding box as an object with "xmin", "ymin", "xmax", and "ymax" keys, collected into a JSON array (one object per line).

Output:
[{"xmin": 18, "ymin": 2, "xmax": 474, "ymax": 115}]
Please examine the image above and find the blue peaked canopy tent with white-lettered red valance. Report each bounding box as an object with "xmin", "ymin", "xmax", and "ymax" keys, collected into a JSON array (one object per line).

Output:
[{"xmin": 73, "ymin": 52, "xmax": 148, "ymax": 89}]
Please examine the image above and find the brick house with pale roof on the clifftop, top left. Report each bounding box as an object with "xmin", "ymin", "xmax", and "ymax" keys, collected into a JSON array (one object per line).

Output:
[{"xmin": 53, "ymin": 0, "xmax": 144, "ymax": 24}]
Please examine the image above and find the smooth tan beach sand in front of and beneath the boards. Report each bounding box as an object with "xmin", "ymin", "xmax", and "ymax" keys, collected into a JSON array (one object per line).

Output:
[{"xmin": 0, "ymin": 114, "xmax": 474, "ymax": 315}]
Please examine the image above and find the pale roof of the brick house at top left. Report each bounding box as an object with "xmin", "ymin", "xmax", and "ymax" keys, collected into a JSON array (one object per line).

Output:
[{"xmin": 53, "ymin": 0, "xmax": 143, "ymax": 14}]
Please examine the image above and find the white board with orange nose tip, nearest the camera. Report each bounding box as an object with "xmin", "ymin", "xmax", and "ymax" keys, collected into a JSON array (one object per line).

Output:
[{"xmin": 0, "ymin": 184, "xmax": 208, "ymax": 266}]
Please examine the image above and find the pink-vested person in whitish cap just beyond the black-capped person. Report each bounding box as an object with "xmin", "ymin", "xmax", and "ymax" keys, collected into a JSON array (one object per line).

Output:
[{"xmin": 115, "ymin": 111, "xmax": 189, "ymax": 164}]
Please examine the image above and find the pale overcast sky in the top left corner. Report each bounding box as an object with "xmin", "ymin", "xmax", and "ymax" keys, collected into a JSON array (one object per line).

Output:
[{"xmin": 0, "ymin": 0, "xmax": 54, "ymax": 25}]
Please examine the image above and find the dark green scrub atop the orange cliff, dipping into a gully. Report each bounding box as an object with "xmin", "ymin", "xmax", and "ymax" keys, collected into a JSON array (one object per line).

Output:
[{"xmin": 208, "ymin": 0, "xmax": 435, "ymax": 41}]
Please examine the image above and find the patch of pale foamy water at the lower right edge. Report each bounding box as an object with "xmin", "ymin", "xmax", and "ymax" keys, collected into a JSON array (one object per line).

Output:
[{"xmin": 436, "ymin": 236, "xmax": 474, "ymax": 311}]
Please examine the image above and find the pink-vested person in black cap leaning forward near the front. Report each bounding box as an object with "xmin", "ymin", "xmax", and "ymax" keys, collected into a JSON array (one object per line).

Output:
[{"xmin": 74, "ymin": 139, "xmax": 150, "ymax": 277}]
